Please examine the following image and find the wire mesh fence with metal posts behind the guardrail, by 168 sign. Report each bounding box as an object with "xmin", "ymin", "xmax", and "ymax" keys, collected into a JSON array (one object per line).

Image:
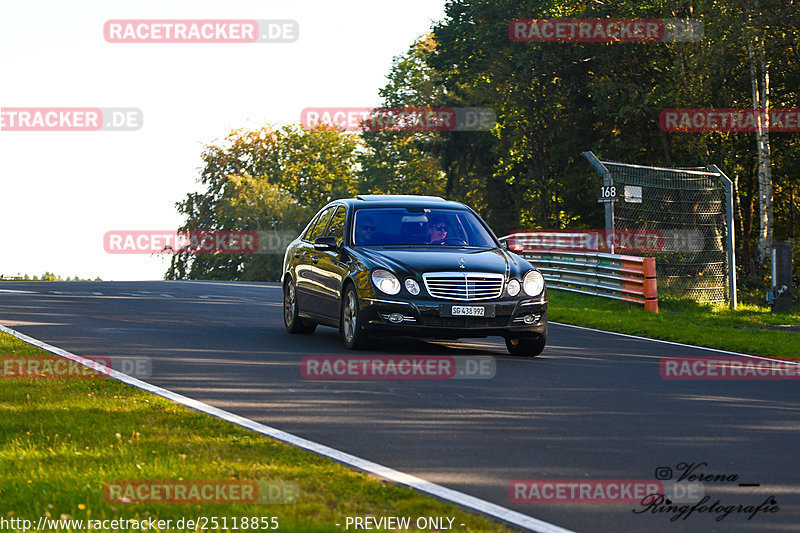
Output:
[{"xmin": 586, "ymin": 152, "xmax": 735, "ymax": 302}]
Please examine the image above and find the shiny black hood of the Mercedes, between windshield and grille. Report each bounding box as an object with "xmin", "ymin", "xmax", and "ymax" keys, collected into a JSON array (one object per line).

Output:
[{"xmin": 358, "ymin": 246, "xmax": 532, "ymax": 276}]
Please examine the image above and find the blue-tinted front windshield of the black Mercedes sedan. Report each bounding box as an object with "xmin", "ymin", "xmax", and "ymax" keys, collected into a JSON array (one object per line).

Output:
[{"xmin": 353, "ymin": 207, "xmax": 497, "ymax": 248}]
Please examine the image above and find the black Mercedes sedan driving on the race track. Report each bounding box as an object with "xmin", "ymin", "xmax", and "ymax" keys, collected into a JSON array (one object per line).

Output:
[{"xmin": 282, "ymin": 195, "xmax": 547, "ymax": 356}]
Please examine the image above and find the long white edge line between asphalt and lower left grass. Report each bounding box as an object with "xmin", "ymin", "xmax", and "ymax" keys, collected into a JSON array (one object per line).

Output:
[{"xmin": 0, "ymin": 325, "xmax": 574, "ymax": 533}]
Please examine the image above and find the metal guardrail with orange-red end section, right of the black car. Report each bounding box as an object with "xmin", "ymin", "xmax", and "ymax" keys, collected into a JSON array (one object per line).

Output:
[{"xmin": 500, "ymin": 235, "xmax": 658, "ymax": 313}]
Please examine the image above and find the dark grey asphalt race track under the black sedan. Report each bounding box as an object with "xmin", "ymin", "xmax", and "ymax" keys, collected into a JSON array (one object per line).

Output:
[{"xmin": 0, "ymin": 281, "xmax": 800, "ymax": 532}]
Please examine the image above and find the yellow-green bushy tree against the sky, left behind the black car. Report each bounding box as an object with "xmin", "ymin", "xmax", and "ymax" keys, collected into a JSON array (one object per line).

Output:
[{"xmin": 165, "ymin": 126, "xmax": 360, "ymax": 281}]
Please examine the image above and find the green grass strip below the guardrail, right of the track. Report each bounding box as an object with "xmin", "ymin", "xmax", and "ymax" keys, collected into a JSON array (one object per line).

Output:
[{"xmin": 548, "ymin": 290, "xmax": 800, "ymax": 360}]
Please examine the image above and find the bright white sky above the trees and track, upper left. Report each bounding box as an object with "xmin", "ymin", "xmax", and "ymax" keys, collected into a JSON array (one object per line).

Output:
[{"xmin": 0, "ymin": 0, "xmax": 445, "ymax": 280}]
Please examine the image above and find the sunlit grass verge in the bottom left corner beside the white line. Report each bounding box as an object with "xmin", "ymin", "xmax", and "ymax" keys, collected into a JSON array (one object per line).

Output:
[{"xmin": 0, "ymin": 333, "xmax": 511, "ymax": 532}]
